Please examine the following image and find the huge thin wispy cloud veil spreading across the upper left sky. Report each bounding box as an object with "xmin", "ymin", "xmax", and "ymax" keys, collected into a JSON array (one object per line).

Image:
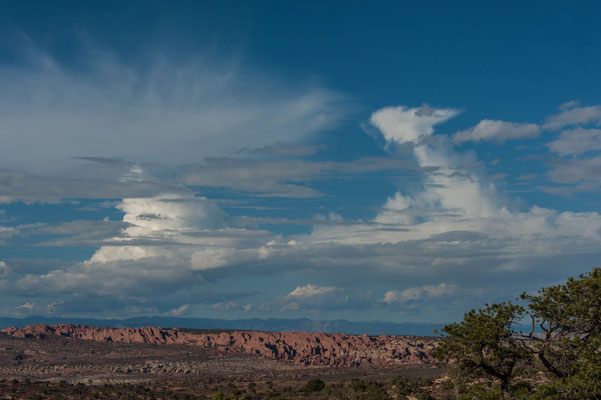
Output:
[{"xmin": 0, "ymin": 45, "xmax": 344, "ymax": 172}]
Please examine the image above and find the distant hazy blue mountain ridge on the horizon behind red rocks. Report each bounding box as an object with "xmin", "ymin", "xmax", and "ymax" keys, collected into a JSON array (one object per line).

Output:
[{"xmin": 0, "ymin": 316, "xmax": 443, "ymax": 336}]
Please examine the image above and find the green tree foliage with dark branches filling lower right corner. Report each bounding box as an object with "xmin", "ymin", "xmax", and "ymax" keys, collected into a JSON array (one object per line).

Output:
[{"xmin": 434, "ymin": 268, "xmax": 601, "ymax": 400}]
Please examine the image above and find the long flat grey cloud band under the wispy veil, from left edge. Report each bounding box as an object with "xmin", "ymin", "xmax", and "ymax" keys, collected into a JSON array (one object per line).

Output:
[{"xmin": 0, "ymin": 157, "xmax": 416, "ymax": 205}]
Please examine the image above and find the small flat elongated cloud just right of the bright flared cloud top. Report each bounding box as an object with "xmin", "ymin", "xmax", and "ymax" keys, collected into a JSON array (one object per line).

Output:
[{"xmin": 453, "ymin": 119, "xmax": 540, "ymax": 143}]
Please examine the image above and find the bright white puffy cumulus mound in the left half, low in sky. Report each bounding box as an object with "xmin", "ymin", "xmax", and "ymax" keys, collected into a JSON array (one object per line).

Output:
[{"xmin": 87, "ymin": 194, "xmax": 273, "ymax": 271}]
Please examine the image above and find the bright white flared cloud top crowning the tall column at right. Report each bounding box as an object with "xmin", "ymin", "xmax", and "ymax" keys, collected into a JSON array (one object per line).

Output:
[{"xmin": 370, "ymin": 104, "xmax": 459, "ymax": 143}]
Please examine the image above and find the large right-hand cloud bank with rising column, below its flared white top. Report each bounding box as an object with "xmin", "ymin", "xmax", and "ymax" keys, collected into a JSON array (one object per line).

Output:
[{"xmin": 299, "ymin": 104, "xmax": 601, "ymax": 310}]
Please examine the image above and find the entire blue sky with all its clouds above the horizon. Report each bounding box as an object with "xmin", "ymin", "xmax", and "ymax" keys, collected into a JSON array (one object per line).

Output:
[{"xmin": 0, "ymin": 0, "xmax": 601, "ymax": 323}]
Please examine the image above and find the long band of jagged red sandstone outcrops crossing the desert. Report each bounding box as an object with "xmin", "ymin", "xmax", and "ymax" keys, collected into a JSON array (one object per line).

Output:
[{"xmin": 2, "ymin": 324, "xmax": 436, "ymax": 367}]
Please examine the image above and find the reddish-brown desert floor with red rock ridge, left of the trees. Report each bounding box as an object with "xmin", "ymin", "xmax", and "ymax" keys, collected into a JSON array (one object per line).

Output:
[{"xmin": 0, "ymin": 325, "xmax": 444, "ymax": 399}]
